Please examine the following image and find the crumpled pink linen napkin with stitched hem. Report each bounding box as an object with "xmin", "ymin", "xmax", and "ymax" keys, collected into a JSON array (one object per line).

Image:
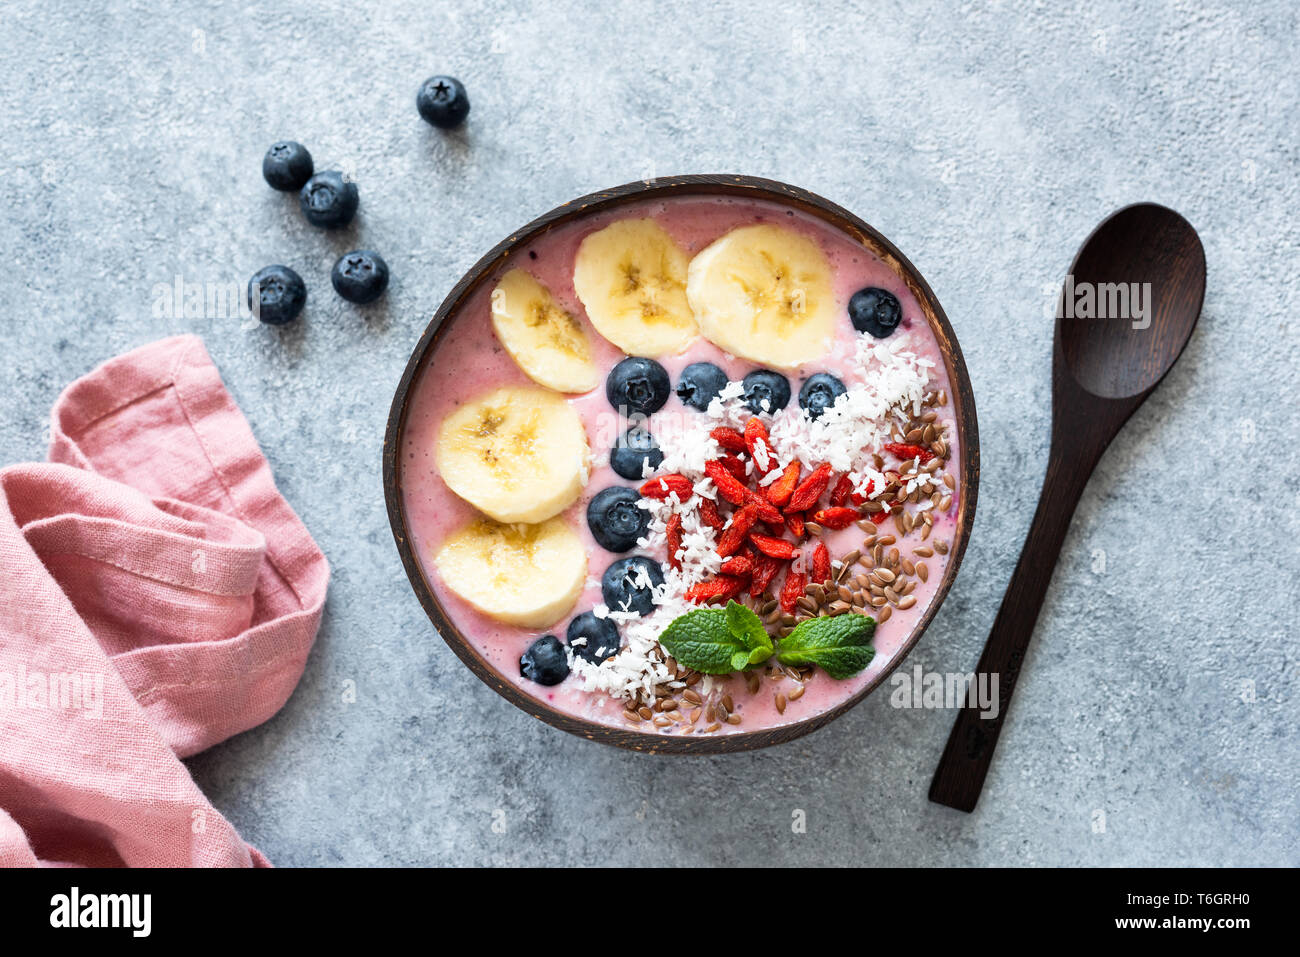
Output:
[{"xmin": 0, "ymin": 335, "xmax": 329, "ymax": 866}]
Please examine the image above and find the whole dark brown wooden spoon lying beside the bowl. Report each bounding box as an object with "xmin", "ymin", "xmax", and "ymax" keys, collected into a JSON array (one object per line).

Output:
[{"xmin": 930, "ymin": 203, "xmax": 1205, "ymax": 811}]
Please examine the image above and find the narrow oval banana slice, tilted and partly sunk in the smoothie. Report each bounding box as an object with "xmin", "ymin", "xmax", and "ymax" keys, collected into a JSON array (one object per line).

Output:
[{"xmin": 491, "ymin": 269, "xmax": 601, "ymax": 393}]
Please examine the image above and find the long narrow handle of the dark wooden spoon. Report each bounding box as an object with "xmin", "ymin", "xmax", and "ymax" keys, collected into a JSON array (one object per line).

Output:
[{"xmin": 930, "ymin": 449, "xmax": 1096, "ymax": 811}]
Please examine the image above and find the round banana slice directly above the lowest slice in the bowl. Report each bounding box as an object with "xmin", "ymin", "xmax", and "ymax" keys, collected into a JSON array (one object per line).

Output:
[{"xmin": 436, "ymin": 386, "xmax": 589, "ymax": 521}]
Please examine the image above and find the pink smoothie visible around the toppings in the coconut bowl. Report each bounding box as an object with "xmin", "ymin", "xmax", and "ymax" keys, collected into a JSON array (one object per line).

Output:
[{"xmin": 402, "ymin": 198, "xmax": 961, "ymax": 733}]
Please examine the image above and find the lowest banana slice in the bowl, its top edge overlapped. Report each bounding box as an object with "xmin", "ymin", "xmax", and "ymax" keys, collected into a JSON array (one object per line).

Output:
[{"xmin": 433, "ymin": 519, "xmax": 586, "ymax": 628}]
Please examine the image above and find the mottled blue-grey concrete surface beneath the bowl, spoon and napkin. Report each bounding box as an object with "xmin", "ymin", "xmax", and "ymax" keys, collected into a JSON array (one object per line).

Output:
[{"xmin": 0, "ymin": 0, "xmax": 1300, "ymax": 865}]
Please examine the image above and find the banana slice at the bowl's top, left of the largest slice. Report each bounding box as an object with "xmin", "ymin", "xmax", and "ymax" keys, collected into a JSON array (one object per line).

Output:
[{"xmin": 573, "ymin": 220, "xmax": 699, "ymax": 358}]
